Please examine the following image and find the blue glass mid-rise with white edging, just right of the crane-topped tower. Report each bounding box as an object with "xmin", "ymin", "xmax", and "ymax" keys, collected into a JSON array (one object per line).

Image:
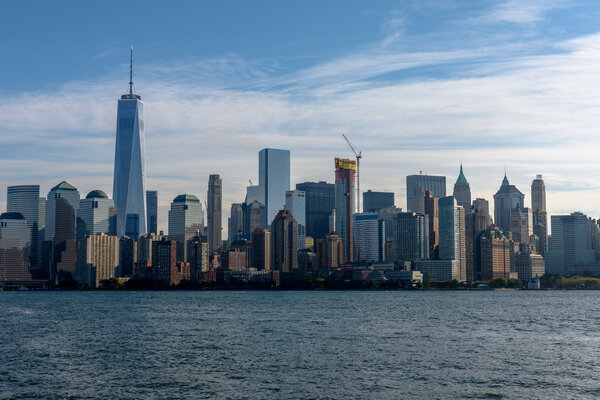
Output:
[{"xmin": 354, "ymin": 213, "xmax": 385, "ymax": 262}]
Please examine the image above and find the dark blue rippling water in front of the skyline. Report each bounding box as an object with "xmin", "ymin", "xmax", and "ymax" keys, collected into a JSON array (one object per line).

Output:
[{"xmin": 0, "ymin": 291, "xmax": 600, "ymax": 399}]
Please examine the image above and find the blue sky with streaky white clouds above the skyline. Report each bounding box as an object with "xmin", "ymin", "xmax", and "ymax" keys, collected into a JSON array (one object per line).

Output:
[{"xmin": 0, "ymin": 0, "xmax": 600, "ymax": 233}]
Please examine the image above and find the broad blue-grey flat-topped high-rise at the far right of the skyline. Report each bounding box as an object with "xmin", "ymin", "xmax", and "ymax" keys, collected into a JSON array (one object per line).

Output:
[{"xmin": 546, "ymin": 212, "xmax": 596, "ymax": 275}]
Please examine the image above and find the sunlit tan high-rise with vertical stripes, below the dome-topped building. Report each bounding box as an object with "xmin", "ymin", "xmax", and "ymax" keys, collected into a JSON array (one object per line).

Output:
[{"xmin": 82, "ymin": 233, "xmax": 121, "ymax": 287}]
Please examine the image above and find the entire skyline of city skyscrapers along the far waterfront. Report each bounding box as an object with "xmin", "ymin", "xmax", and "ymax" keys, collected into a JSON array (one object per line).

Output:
[{"xmin": 0, "ymin": 61, "xmax": 600, "ymax": 288}]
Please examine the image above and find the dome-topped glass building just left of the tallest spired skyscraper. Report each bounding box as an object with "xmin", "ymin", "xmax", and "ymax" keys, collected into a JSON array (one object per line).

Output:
[{"xmin": 77, "ymin": 190, "xmax": 117, "ymax": 236}]
